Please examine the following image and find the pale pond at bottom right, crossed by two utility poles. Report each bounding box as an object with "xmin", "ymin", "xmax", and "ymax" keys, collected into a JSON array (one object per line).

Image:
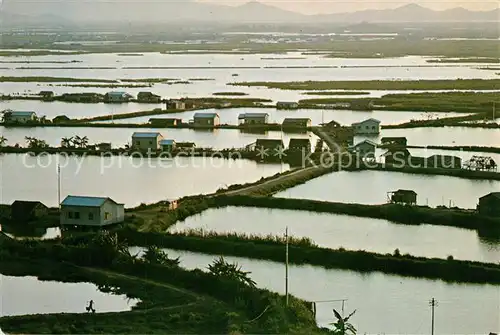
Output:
[{"xmin": 127, "ymin": 248, "xmax": 500, "ymax": 334}]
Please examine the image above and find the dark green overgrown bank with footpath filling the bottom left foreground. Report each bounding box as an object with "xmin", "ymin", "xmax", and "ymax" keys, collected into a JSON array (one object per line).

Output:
[{"xmin": 0, "ymin": 238, "xmax": 319, "ymax": 334}]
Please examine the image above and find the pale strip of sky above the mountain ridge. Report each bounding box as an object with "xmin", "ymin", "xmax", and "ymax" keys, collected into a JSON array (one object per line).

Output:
[{"xmin": 197, "ymin": 0, "xmax": 500, "ymax": 14}]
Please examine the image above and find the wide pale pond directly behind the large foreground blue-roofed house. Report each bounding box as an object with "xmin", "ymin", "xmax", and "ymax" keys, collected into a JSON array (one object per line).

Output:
[{"xmin": 0, "ymin": 154, "xmax": 289, "ymax": 207}]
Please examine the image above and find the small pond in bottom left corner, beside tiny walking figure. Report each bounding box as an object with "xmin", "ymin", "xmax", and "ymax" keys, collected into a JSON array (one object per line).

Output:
[{"xmin": 0, "ymin": 275, "xmax": 138, "ymax": 316}]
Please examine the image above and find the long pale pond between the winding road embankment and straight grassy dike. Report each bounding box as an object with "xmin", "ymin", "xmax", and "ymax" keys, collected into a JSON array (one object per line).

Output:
[{"xmin": 169, "ymin": 207, "xmax": 500, "ymax": 263}]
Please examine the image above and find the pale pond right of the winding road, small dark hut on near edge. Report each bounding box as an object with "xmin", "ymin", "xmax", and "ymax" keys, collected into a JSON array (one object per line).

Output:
[{"xmin": 275, "ymin": 171, "xmax": 500, "ymax": 209}]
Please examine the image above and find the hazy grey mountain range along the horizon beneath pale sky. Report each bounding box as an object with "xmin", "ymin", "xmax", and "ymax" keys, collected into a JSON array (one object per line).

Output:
[{"xmin": 0, "ymin": 0, "xmax": 500, "ymax": 25}]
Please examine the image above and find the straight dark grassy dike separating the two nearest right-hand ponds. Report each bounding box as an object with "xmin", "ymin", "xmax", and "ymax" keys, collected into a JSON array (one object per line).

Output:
[{"xmin": 120, "ymin": 231, "xmax": 500, "ymax": 284}]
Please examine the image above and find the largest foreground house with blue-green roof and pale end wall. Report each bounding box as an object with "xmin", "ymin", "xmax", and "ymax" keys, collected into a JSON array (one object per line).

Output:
[{"xmin": 60, "ymin": 195, "xmax": 125, "ymax": 227}]
